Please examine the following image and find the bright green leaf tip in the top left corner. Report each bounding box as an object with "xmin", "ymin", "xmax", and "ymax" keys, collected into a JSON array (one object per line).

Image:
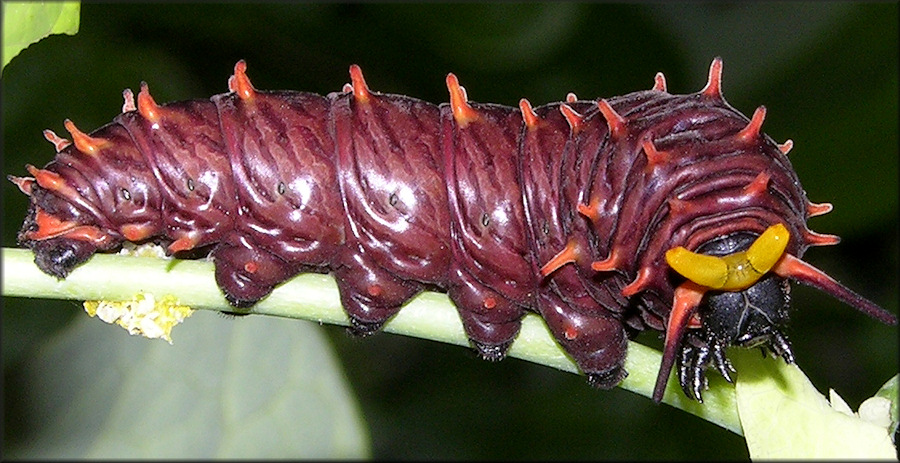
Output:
[{"xmin": 3, "ymin": 2, "xmax": 81, "ymax": 68}]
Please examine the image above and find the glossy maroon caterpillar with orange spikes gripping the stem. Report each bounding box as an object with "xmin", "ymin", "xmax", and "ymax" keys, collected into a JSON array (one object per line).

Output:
[{"xmin": 8, "ymin": 58, "xmax": 897, "ymax": 402}]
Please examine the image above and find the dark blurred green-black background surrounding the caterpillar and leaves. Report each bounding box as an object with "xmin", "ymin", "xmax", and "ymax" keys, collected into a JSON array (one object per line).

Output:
[{"xmin": 0, "ymin": 2, "xmax": 898, "ymax": 459}]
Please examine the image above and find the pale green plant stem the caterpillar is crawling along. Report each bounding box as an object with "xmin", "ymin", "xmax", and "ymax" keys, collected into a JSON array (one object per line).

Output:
[{"xmin": 2, "ymin": 248, "xmax": 742, "ymax": 435}]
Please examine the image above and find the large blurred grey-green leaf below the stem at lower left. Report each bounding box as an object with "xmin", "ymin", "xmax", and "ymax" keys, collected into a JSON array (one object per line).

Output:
[{"xmin": 5, "ymin": 312, "xmax": 369, "ymax": 458}]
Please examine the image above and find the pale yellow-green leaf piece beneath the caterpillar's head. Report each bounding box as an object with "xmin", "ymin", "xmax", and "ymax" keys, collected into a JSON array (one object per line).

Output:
[{"xmin": 730, "ymin": 351, "xmax": 896, "ymax": 459}]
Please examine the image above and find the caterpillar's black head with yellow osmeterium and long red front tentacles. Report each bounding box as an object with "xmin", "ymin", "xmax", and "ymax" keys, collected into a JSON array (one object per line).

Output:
[{"xmin": 653, "ymin": 224, "xmax": 897, "ymax": 402}]
